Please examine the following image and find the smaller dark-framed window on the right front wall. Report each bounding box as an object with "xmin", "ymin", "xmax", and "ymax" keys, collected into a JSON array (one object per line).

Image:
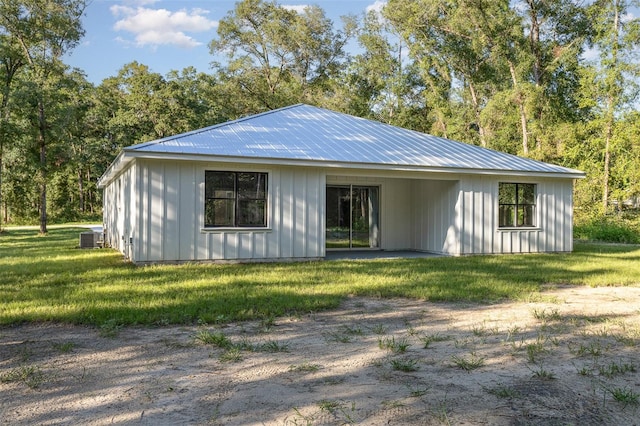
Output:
[{"xmin": 498, "ymin": 182, "xmax": 536, "ymax": 228}]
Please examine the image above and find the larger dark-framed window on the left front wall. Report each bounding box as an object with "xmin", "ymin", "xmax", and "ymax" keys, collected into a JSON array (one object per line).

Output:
[{"xmin": 204, "ymin": 171, "xmax": 267, "ymax": 227}]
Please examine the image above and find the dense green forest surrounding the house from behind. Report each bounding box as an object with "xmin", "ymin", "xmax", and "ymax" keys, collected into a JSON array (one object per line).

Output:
[{"xmin": 0, "ymin": 0, "xmax": 640, "ymax": 243}]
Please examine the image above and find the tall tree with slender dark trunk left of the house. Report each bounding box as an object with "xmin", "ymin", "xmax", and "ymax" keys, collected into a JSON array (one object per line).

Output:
[{"xmin": 0, "ymin": 0, "xmax": 86, "ymax": 234}]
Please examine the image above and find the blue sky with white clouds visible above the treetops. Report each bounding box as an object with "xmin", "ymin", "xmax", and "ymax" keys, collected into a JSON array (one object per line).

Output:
[{"xmin": 65, "ymin": 0, "xmax": 385, "ymax": 84}]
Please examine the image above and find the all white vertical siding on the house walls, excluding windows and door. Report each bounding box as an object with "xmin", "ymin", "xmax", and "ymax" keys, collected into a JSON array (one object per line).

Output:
[{"xmin": 104, "ymin": 160, "xmax": 573, "ymax": 262}]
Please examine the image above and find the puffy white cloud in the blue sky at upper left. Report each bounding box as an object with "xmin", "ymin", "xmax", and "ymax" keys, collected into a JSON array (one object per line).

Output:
[{"xmin": 110, "ymin": 4, "xmax": 218, "ymax": 48}]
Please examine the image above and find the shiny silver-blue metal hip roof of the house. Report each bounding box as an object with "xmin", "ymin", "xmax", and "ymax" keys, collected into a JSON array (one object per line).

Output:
[{"xmin": 101, "ymin": 104, "xmax": 584, "ymax": 186}]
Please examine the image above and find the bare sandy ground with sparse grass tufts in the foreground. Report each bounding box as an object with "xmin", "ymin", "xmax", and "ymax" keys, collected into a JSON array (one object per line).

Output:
[{"xmin": 0, "ymin": 287, "xmax": 640, "ymax": 425}]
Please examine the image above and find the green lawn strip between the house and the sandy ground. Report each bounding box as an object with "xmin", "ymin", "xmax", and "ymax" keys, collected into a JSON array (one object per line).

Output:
[{"xmin": 0, "ymin": 228, "xmax": 640, "ymax": 325}]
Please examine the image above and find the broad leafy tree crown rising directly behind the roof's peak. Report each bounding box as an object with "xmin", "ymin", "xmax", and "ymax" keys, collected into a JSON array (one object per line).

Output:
[{"xmin": 209, "ymin": 0, "xmax": 355, "ymax": 115}]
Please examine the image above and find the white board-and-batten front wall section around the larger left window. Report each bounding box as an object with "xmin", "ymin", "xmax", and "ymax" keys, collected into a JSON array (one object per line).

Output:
[{"xmin": 120, "ymin": 160, "xmax": 325, "ymax": 263}]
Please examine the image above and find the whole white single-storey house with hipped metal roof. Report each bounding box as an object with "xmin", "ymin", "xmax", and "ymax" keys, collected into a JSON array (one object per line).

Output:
[{"xmin": 98, "ymin": 105, "xmax": 584, "ymax": 264}]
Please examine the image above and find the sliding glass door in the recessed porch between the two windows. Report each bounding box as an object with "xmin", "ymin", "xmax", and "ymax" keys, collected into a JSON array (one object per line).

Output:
[{"xmin": 326, "ymin": 185, "xmax": 380, "ymax": 249}]
